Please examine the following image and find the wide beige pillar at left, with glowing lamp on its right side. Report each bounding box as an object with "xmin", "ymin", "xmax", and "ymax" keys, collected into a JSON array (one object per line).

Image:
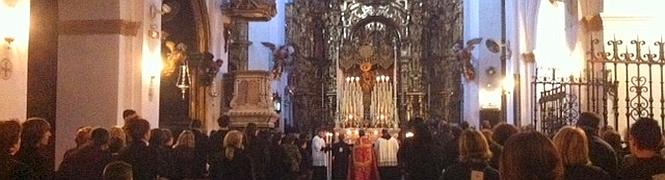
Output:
[{"xmin": 55, "ymin": 0, "xmax": 161, "ymax": 167}]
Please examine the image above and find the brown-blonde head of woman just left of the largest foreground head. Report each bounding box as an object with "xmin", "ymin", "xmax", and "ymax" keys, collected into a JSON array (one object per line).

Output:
[{"xmin": 459, "ymin": 129, "xmax": 492, "ymax": 162}]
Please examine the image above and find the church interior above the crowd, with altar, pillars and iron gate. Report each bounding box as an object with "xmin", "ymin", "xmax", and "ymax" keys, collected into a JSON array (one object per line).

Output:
[{"xmin": 0, "ymin": 0, "xmax": 665, "ymax": 178}]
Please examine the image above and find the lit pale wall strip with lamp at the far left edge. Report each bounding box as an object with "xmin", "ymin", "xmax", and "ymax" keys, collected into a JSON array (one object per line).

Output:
[{"xmin": 0, "ymin": 0, "xmax": 30, "ymax": 121}]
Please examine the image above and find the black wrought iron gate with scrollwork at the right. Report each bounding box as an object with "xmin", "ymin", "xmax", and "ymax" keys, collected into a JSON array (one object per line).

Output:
[{"xmin": 531, "ymin": 39, "xmax": 665, "ymax": 134}]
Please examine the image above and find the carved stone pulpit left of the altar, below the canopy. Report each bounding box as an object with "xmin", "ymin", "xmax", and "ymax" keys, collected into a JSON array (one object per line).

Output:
[{"xmin": 226, "ymin": 71, "xmax": 279, "ymax": 128}]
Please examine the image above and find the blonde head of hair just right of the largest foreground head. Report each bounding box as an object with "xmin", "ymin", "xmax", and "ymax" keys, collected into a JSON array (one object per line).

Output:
[{"xmin": 554, "ymin": 126, "xmax": 591, "ymax": 166}]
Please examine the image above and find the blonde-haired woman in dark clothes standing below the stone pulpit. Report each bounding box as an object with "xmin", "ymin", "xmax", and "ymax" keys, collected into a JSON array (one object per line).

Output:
[{"xmin": 210, "ymin": 130, "xmax": 255, "ymax": 180}]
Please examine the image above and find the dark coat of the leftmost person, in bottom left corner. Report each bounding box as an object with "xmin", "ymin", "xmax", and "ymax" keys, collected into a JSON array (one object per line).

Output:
[{"xmin": 0, "ymin": 153, "xmax": 36, "ymax": 180}]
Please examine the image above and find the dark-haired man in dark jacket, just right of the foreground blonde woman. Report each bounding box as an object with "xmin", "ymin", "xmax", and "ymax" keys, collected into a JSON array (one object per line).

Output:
[{"xmin": 577, "ymin": 112, "xmax": 618, "ymax": 177}]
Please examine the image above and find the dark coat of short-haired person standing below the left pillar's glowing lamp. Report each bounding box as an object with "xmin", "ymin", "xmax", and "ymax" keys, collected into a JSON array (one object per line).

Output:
[{"xmin": 118, "ymin": 140, "xmax": 166, "ymax": 180}]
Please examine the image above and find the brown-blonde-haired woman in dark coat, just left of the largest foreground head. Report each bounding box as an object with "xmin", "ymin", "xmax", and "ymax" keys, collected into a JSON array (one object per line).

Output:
[{"xmin": 443, "ymin": 129, "xmax": 499, "ymax": 180}]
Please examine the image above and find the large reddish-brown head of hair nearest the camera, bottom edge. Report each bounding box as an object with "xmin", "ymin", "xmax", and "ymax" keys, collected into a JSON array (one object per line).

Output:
[{"xmin": 499, "ymin": 131, "xmax": 563, "ymax": 180}]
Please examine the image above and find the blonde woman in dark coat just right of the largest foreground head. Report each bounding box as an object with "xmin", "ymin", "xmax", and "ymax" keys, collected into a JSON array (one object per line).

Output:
[{"xmin": 554, "ymin": 126, "xmax": 610, "ymax": 180}]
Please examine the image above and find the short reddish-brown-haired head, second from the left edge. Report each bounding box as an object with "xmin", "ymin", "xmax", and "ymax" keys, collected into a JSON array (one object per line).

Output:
[{"xmin": 21, "ymin": 117, "xmax": 51, "ymax": 148}]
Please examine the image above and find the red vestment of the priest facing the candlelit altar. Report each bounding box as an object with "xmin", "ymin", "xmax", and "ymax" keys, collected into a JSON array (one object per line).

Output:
[{"xmin": 348, "ymin": 136, "xmax": 379, "ymax": 180}]
